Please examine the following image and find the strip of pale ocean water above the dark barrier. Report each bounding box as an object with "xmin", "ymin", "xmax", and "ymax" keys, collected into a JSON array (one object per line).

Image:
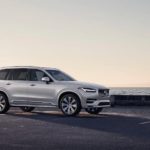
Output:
[{"xmin": 110, "ymin": 87, "xmax": 150, "ymax": 95}]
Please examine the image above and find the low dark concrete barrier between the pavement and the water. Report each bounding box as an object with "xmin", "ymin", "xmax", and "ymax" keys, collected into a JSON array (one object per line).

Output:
[{"xmin": 111, "ymin": 95, "xmax": 150, "ymax": 106}]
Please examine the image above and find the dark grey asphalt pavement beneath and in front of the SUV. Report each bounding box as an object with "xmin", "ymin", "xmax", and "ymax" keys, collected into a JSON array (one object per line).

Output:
[{"xmin": 0, "ymin": 107, "xmax": 150, "ymax": 150}]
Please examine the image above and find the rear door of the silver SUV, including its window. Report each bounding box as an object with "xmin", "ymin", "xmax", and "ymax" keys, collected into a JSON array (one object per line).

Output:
[{"xmin": 6, "ymin": 68, "xmax": 29, "ymax": 105}]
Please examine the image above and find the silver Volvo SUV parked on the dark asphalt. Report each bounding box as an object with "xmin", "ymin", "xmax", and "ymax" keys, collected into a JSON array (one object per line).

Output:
[{"xmin": 0, "ymin": 67, "xmax": 110, "ymax": 116}]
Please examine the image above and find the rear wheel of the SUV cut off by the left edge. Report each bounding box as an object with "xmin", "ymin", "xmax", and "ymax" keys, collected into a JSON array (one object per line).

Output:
[{"xmin": 0, "ymin": 93, "xmax": 10, "ymax": 114}]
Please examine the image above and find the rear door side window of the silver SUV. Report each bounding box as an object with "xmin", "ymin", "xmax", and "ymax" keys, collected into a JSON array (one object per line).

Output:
[{"xmin": 12, "ymin": 69, "xmax": 28, "ymax": 80}]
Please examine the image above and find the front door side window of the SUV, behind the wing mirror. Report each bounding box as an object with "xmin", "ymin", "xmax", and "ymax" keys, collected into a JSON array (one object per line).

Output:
[{"xmin": 30, "ymin": 69, "xmax": 48, "ymax": 81}]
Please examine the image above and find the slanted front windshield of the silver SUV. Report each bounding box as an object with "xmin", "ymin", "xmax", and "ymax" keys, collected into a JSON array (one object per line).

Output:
[{"xmin": 46, "ymin": 70, "xmax": 75, "ymax": 81}]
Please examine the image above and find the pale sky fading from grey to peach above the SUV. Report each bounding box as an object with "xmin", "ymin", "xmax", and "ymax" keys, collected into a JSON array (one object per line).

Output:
[{"xmin": 0, "ymin": 0, "xmax": 150, "ymax": 87}]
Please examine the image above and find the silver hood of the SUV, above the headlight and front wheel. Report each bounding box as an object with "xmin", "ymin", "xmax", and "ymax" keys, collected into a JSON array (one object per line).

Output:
[{"xmin": 57, "ymin": 81, "xmax": 107, "ymax": 89}]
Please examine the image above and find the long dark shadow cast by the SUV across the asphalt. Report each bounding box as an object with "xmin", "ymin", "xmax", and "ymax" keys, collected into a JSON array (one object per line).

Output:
[{"xmin": 8, "ymin": 111, "xmax": 150, "ymax": 140}]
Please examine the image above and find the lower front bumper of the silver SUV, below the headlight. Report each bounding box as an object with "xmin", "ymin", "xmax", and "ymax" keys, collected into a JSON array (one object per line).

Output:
[{"xmin": 87, "ymin": 100, "xmax": 111, "ymax": 108}]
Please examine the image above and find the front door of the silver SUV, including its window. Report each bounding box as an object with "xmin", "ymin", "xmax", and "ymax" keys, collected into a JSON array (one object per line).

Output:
[{"xmin": 27, "ymin": 69, "xmax": 56, "ymax": 106}]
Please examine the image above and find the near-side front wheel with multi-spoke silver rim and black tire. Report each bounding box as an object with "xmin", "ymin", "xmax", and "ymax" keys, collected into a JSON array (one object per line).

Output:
[{"xmin": 59, "ymin": 94, "xmax": 81, "ymax": 116}]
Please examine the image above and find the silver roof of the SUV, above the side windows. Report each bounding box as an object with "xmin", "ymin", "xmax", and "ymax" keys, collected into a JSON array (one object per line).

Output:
[{"xmin": 0, "ymin": 66, "xmax": 58, "ymax": 70}]
